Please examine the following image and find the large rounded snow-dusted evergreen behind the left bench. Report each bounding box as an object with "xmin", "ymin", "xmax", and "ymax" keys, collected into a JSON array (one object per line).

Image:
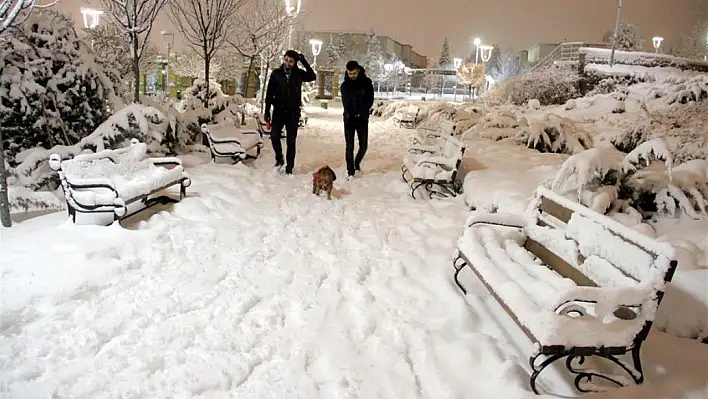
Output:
[{"xmin": 0, "ymin": 9, "xmax": 117, "ymax": 163}]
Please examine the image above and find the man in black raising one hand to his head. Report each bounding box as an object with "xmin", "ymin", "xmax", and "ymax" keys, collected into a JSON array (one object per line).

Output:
[{"xmin": 263, "ymin": 50, "xmax": 317, "ymax": 175}]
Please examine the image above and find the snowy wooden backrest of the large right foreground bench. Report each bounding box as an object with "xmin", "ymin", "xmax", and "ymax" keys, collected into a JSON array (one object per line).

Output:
[{"xmin": 525, "ymin": 187, "xmax": 677, "ymax": 339}]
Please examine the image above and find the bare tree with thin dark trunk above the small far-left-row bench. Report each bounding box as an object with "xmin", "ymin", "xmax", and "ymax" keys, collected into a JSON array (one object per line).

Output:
[{"xmin": 170, "ymin": 0, "xmax": 245, "ymax": 107}]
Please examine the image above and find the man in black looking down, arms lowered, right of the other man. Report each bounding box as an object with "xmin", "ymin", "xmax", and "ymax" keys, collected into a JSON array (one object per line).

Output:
[{"xmin": 340, "ymin": 61, "xmax": 374, "ymax": 179}]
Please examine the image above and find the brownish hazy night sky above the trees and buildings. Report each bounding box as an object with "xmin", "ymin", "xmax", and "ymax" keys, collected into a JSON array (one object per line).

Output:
[{"xmin": 57, "ymin": 0, "xmax": 705, "ymax": 57}]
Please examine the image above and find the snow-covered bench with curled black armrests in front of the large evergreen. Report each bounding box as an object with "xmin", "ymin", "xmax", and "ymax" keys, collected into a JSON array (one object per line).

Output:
[{"xmin": 49, "ymin": 139, "xmax": 191, "ymax": 223}]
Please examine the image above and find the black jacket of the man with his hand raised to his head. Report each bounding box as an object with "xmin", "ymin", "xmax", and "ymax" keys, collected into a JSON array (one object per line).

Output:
[{"xmin": 265, "ymin": 60, "xmax": 317, "ymax": 113}]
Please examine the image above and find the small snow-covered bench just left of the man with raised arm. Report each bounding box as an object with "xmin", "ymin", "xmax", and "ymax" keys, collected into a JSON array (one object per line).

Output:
[{"xmin": 202, "ymin": 122, "xmax": 263, "ymax": 163}]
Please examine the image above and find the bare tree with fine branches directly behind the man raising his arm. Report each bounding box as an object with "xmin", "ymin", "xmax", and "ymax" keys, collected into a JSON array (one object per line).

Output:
[{"xmin": 227, "ymin": 0, "xmax": 292, "ymax": 100}]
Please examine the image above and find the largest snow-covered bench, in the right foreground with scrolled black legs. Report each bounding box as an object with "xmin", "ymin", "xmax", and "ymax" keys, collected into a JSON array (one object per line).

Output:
[{"xmin": 453, "ymin": 187, "xmax": 677, "ymax": 394}]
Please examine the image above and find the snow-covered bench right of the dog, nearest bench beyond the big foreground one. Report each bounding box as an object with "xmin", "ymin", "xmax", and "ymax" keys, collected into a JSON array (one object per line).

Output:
[{"xmin": 401, "ymin": 136, "xmax": 465, "ymax": 198}]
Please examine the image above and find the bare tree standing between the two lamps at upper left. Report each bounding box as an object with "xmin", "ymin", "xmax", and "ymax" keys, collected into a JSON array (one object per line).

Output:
[{"xmin": 101, "ymin": 0, "xmax": 169, "ymax": 103}]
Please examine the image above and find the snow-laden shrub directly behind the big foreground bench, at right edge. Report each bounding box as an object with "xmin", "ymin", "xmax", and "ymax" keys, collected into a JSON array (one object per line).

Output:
[{"xmin": 551, "ymin": 138, "xmax": 708, "ymax": 220}]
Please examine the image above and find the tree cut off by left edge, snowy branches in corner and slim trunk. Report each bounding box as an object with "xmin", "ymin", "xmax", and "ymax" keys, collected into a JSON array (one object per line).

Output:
[{"xmin": 0, "ymin": 0, "xmax": 56, "ymax": 227}]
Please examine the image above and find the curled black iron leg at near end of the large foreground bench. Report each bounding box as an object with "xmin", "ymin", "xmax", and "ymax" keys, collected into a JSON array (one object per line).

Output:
[{"xmin": 529, "ymin": 344, "xmax": 644, "ymax": 395}]
